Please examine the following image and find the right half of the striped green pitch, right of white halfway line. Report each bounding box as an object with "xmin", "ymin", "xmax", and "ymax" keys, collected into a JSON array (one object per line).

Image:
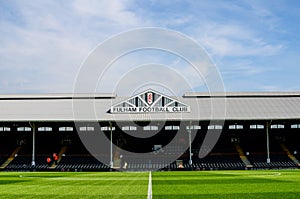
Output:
[{"xmin": 152, "ymin": 170, "xmax": 300, "ymax": 199}]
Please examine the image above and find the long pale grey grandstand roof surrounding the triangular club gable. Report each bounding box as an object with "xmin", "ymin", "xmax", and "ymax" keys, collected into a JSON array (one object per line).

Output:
[{"xmin": 0, "ymin": 92, "xmax": 300, "ymax": 121}]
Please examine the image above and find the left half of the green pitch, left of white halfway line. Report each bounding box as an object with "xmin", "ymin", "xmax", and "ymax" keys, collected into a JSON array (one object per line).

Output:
[{"xmin": 0, "ymin": 172, "xmax": 149, "ymax": 199}]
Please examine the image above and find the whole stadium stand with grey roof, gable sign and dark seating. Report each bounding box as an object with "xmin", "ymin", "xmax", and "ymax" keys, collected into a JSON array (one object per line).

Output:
[{"xmin": 0, "ymin": 89, "xmax": 300, "ymax": 171}]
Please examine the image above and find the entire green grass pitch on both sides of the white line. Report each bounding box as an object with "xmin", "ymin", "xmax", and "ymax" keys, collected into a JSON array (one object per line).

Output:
[{"xmin": 0, "ymin": 170, "xmax": 300, "ymax": 199}]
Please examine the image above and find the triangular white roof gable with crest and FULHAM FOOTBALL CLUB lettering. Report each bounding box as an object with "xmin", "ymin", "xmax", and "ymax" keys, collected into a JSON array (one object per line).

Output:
[{"xmin": 110, "ymin": 89, "xmax": 190, "ymax": 113}]
